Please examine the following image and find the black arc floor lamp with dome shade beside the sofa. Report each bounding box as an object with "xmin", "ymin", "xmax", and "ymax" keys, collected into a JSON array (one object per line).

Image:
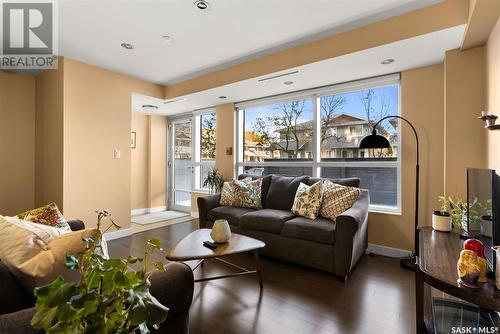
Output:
[{"xmin": 359, "ymin": 116, "xmax": 420, "ymax": 271}]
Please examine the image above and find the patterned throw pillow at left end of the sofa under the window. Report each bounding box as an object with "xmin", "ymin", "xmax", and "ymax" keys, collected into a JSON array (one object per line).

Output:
[{"xmin": 219, "ymin": 177, "xmax": 262, "ymax": 209}]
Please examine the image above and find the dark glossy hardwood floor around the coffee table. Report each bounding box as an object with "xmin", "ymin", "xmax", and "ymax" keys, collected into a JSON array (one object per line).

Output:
[{"xmin": 108, "ymin": 220, "xmax": 415, "ymax": 334}]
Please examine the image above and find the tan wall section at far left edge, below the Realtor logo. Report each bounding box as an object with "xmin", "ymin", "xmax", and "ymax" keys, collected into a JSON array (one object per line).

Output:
[{"xmin": 0, "ymin": 71, "xmax": 35, "ymax": 215}]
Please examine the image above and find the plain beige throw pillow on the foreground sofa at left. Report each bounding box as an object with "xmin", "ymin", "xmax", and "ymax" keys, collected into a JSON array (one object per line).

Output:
[{"xmin": 0, "ymin": 216, "xmax": 107, "ymax": 290}]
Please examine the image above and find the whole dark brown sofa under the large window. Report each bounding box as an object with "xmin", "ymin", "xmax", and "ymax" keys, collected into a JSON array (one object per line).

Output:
[{"xmin": 198, "ymin": 174, "xmax": 370, "ymax": 280}]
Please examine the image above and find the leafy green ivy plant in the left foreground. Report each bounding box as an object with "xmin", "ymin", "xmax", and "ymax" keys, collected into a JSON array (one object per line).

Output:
[{"xmin": 31, "ymin": 210, "xmax": 168, "ymax": 334}]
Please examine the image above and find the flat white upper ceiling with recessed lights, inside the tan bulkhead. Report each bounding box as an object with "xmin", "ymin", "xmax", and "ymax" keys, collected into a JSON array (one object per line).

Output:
[{"xmin": 59, "ymin": 0, "xmax": 440, "ymax": 84}]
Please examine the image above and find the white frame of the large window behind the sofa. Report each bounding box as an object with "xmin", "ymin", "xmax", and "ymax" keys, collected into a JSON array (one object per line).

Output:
[{"xmin": 235, "ymin": 73, "xmax": 404, "ymax": 215}]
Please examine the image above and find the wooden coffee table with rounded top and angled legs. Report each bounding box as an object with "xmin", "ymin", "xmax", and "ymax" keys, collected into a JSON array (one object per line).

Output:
[{"xmin": 166, "ymin": 228, "xmax": 266, "ymax": 289}]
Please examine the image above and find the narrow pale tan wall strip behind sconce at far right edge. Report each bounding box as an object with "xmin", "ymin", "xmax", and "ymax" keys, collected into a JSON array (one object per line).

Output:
[{"xmin": 483, "ymin": 19, "xmax": 500, "ymax": 169}]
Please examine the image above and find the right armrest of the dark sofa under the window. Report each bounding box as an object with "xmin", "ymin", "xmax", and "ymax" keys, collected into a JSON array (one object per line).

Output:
[{"xmin": 334, "ymin": 190, "xmax": 370, "ymax": 277}]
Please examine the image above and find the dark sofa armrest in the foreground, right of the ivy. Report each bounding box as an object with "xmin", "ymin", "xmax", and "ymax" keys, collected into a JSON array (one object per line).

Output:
[{"xmin": 149, "ymin": 262, "xmax": 194, "ymax": 334}]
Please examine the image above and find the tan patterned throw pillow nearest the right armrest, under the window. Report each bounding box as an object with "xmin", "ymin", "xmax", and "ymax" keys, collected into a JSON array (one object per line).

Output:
[{"xmin": 320, "ymin": 180, "xmax": 361, "ymax": 220}]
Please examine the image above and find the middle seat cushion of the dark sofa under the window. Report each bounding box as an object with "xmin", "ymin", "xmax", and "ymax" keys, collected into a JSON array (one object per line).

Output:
[{"xmin": 240, "ymin": 209, "xmax": 295, "ymax": 234}]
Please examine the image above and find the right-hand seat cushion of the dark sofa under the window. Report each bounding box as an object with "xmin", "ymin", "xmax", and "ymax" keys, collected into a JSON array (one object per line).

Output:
[{"xmin": 281, "ymin": 217, "xmax": 335, "ymax": 245}]
